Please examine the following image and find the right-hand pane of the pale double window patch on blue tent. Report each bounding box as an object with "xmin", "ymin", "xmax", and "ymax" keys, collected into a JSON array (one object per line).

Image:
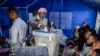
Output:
[{"xmin": 60, "ymin": 12, "xmax": 72, "ymax": 29}]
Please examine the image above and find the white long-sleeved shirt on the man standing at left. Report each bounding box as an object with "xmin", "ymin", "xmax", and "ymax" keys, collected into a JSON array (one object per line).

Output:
[{"xmin": 9, "ymin": 18, "xmax": 27, "ymax": 50}]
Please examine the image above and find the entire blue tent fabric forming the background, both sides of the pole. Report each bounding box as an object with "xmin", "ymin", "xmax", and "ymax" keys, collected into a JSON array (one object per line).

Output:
[{"xmin": 0, "ymin": 0, "xmax": 97, "ymax": 38}]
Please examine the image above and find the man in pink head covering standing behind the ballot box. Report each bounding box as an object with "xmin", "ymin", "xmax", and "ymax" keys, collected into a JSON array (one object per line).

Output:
[{"xmin": 29, "ymin": 8, "xmax": 48, "ymax": 30}]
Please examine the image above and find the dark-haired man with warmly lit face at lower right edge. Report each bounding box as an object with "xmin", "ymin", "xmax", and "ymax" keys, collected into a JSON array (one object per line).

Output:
[{"xmin": 87, "ymin": 34, "xmax": 100, "ymax": 56}]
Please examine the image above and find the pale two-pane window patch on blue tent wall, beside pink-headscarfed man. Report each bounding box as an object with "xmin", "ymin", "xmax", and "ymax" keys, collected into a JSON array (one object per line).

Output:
[{"xmin": 49, "ymin": 12, "xmax": 72, "ymax": 29}]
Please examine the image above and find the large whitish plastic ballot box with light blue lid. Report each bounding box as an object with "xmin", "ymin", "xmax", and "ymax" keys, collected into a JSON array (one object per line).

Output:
[{"xmin": 33, "ymin": 29, "xmax": 62, "ymax": 56}]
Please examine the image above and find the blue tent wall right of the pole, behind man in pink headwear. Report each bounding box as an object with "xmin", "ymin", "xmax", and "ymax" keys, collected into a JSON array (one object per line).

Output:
[{"xmin": 28, "ymin": 0, "xmax": 97, "ymax": 38}]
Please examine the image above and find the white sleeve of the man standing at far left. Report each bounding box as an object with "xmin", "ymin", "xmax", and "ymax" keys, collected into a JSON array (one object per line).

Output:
[{"xmin": 10, "ymin": 27, "xmax": 18, "ymax": 44}]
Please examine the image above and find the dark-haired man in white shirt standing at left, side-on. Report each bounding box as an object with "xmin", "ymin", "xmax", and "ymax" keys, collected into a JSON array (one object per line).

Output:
[{"xmin": 8, "ymin": 7, "xmax": 27, "ymax": 52}]
